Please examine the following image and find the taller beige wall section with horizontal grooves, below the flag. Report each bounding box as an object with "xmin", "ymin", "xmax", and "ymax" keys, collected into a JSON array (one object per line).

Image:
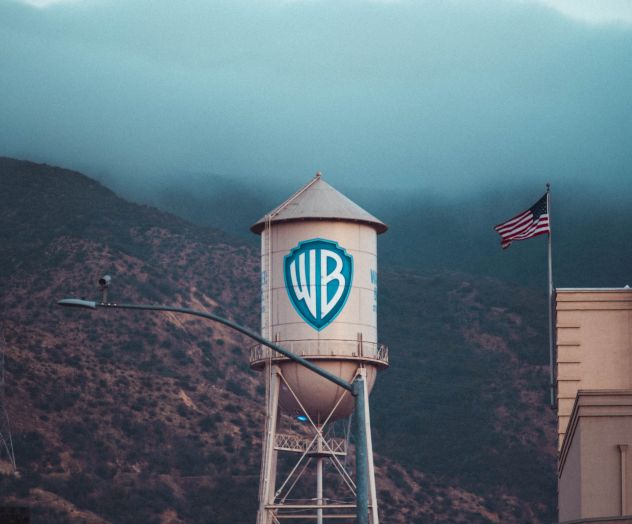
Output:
[{"xmin": 557, "ymin": 288, "xmax": 632, "ymax": 449}]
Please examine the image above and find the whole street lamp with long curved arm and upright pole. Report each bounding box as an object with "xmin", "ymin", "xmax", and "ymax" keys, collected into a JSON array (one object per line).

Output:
[{"xmin": 57, "ymin": 296, "xmax": 369, "ymax": 524}]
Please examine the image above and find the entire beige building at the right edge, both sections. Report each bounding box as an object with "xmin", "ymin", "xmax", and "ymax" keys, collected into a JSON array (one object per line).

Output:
[{"xmin": 556, "ymin": 288, "xmax": 632, "ymax": 523}]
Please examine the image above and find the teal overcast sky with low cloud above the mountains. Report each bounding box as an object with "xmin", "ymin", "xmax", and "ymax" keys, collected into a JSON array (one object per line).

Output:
[{"xmin": 0, "ymin": 0, "xmax": 632, "ymax": 195}]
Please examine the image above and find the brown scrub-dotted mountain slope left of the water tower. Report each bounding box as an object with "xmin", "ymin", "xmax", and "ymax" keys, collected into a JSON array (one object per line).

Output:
[{"xmin": 0, "ymin": 161, "xmax": 262, "ymax": 522}]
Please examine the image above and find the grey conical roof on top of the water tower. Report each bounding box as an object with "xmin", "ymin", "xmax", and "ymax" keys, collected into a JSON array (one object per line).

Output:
[{"xmin": 250, "ymin": 173, "xmax": 388, "ymax": 235}]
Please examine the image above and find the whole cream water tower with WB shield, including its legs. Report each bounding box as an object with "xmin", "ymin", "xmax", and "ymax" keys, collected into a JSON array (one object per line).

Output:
[{"xmin": 250, "ymin": 173, "xmax": 388, "ymax": 524}]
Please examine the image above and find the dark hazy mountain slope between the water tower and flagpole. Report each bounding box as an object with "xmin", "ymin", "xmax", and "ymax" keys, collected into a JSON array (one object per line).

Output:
[{"xmin": 372, "ymin": 272, "xmax": 555, "ymax": 521}]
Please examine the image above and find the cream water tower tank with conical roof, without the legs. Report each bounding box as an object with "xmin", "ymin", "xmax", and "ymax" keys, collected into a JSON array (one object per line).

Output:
[{"xmin": 251, "ymin": 174, "xmax": 388, "ymax": 423}]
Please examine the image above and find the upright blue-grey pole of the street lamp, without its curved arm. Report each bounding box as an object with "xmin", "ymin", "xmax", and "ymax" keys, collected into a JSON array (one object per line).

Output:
[{"xmin": 353, "ymin": 375, "xmax": 369, "ymax": 524}]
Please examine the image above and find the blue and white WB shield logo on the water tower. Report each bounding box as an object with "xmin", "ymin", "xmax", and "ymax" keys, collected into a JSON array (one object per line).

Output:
[{"xmin": 283, "ymin": 238, "xmax": 353, "ymax": 331}]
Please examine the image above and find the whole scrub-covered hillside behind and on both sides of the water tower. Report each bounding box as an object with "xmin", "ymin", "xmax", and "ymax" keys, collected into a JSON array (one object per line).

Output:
[{"xmin": 0, "ymin": 159, "xmax": 555, "ymax": 523}]
